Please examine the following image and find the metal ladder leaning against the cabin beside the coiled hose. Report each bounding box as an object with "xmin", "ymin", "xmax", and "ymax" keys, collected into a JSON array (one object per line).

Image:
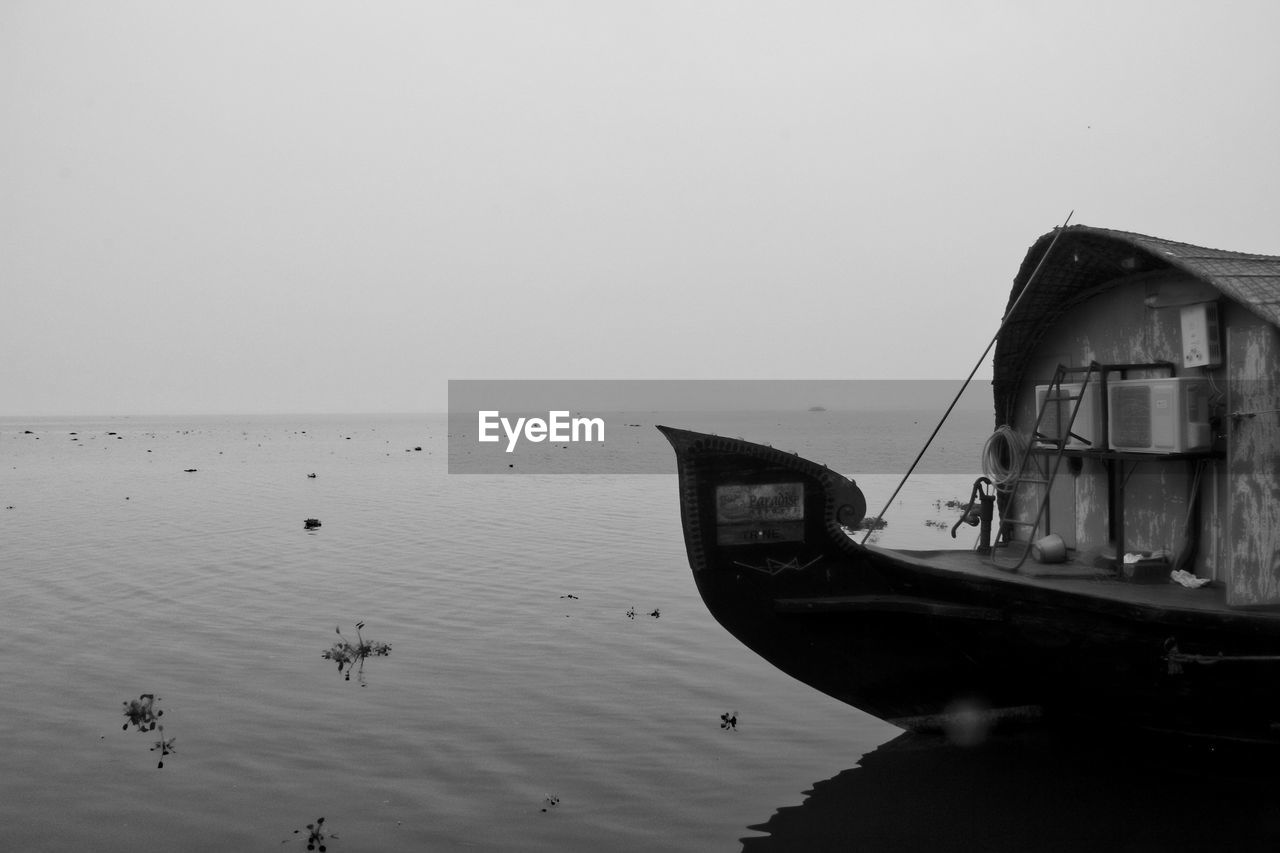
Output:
[{"xmin": 991, "ymin": 361, "xmax": 1103, "ymax": 571}]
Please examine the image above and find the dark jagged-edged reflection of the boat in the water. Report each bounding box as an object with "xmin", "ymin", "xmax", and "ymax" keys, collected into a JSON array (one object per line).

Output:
[{"xmin": 742, "ymin": 733, "xmax": 1280, "ymax": 853}]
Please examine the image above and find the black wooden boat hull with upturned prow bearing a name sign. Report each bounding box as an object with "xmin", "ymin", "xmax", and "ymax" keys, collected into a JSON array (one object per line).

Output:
[{"xmin": 659, "ymin": 428, "xmax": 1280, "ymax": 743}]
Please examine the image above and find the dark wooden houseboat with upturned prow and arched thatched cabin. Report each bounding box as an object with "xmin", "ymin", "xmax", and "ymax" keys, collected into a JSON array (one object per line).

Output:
[{"xmin": 659, "ymin": 225, "xmax": 1280, "ymax": 743}]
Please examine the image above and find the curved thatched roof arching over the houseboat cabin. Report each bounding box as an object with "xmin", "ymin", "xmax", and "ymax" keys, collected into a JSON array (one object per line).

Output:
[{"xmin": 993, "ymin": 225, "xmax": 1280, "ymax": 421}]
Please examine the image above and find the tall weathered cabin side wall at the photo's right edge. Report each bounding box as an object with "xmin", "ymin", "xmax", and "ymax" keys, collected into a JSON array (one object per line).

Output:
[{"xmin": 1224, "ymin": 310, "xmax": 1280, "ymax": 606}]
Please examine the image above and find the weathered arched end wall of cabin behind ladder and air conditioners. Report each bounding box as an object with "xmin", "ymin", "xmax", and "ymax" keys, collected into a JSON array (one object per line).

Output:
[{"xmin": 1011, "ymin": 272, "xmax": 1228, "ymax": 578}]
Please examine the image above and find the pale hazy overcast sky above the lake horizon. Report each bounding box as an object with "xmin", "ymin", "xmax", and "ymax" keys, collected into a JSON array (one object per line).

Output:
[{"xmin": 0, "ymin": 0, "xmax": 1280, "ymax": 415}]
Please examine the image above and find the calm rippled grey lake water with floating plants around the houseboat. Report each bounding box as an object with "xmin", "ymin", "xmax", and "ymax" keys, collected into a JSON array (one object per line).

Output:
[{"xmin": 0, "ymin": 412, "xmax": 1277, "ymax": 853}]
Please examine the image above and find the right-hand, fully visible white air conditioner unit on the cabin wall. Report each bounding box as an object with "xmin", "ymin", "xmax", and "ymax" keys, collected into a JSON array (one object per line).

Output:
[{"xmin": 1107, "ymin": 377, "xmax": 1213, "ymax": 453}]
